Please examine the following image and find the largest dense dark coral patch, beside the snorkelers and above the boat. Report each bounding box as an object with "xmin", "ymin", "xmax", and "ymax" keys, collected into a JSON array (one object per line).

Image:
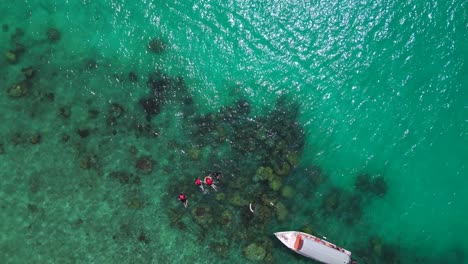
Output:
[{"xmin": 161, "ymin": 94, "xmax": 304, "ymax": 262}]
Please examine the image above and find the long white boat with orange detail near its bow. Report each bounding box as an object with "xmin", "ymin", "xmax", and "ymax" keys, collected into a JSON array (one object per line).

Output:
[{"xmin": 275, "ymin": 231, "xmax": 355, "ymax": 264}]
